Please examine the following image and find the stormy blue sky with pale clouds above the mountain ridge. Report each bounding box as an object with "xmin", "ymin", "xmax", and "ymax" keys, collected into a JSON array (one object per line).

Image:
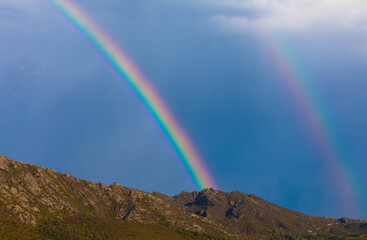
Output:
[{"xmin": 0, "ymin": 0, "xmax": 367, "ymax": 219}]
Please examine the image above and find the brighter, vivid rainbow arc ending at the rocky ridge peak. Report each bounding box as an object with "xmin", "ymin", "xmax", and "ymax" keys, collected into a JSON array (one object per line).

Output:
[{"xmin": 47, "ymin": 0, "xmax": 217, "ymax": 190}]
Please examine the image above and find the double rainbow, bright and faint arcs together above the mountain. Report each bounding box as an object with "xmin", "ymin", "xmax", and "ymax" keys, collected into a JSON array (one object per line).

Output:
[{"xmin": 47, "ymin": 0, "xmax": 360, "ymax": 217}]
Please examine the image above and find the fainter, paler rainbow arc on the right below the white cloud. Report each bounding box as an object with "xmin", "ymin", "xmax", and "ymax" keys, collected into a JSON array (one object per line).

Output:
[{"xmin": 262, "ymin": 34, "xmax": 361, "ymax": 217}]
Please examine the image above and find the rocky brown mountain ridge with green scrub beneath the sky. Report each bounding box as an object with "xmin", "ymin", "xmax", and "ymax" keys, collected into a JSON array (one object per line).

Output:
[{"xmin": 0, "ymin": 155, "xmax": 367, "ymax": 240}]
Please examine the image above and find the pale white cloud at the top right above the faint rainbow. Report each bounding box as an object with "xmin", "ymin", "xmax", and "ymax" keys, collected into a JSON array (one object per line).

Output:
[{"xmin": 206, "ymin": 0, "xmax": 367, "ymax": 31}]
